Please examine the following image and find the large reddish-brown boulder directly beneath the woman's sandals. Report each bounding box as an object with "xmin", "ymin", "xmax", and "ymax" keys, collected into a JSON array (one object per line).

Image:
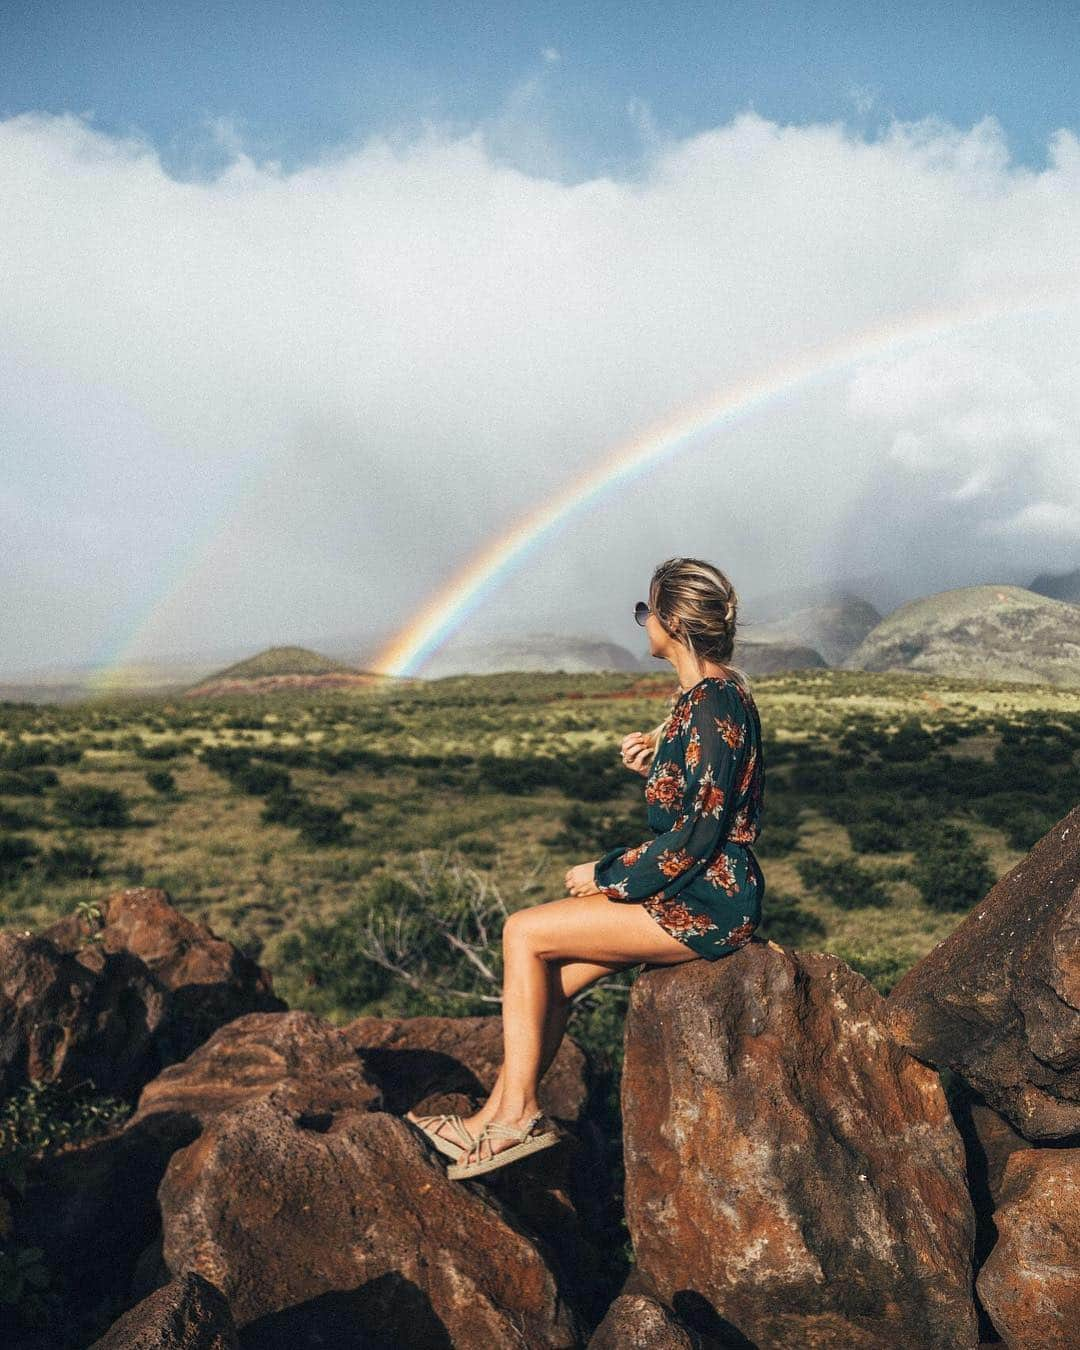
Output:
[{"xmin": 158, "ymin": 1094, "xmax": 582, "ymax": 1350}]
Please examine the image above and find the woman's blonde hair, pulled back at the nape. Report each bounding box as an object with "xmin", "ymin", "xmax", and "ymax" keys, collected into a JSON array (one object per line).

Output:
[{"xmin": 649, "ymin": 558, "xmax": 749, "ymax": 760}]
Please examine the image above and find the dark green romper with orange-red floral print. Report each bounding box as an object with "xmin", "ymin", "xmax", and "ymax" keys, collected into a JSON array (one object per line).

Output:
[{"xmin": 594, "ymin": 675, "xmax": 765, "ymax": 961}]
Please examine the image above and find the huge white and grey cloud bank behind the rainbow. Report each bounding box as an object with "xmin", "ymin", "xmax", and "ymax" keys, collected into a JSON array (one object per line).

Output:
[{"xmin": 0, "ymin": 103, "xmax": 1080, "ymax": 671}]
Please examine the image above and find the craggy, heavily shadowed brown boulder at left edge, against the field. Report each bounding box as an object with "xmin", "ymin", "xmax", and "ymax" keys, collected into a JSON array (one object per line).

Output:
[{"xmin": 0, "ymin": 887, "xmax": 286, "ymax": 1100}]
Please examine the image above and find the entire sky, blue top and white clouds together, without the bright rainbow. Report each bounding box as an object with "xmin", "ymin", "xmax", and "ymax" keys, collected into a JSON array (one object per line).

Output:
[{"xmin": 0, "ymin": 0, "xmax": 1080, "ymax": 678}]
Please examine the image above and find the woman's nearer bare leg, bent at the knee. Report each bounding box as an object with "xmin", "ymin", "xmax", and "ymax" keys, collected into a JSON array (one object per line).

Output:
[{"xmin": 450, "ymin": 894, "xmax": 699, "ymax": 1158}]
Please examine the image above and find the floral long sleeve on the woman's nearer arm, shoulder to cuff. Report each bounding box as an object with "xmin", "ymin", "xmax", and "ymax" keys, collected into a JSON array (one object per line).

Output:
[{"xmin": 594, "ymin": 682, "xmax": 749, "ymax": 900}]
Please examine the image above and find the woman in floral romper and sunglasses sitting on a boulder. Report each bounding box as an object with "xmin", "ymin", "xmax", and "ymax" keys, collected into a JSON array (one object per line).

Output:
[{"xmin": 406, "ymin": 558, "xmax": 765, "ymax": 1179}]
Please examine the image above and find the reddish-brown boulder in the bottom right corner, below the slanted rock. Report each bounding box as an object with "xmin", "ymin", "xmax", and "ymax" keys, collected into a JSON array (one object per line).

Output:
[{"xmin": 976, "ymin": 1148, "xmax": 1080, "ymax": 1350}]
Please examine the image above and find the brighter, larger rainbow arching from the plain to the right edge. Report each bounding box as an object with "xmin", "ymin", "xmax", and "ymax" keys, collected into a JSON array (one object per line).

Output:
[{"xmin": 365, "ymin": 278, "xmax": 1080, "ymax": 675}]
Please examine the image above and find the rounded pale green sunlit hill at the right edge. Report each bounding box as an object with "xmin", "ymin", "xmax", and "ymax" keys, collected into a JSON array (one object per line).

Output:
[{"xmin": 841, "ymin": 585, "xmax": 1080, "ymax": 684}]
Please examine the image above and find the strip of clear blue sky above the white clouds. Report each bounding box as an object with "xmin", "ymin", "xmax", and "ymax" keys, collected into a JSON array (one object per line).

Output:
[{"xmin": 0, "ymin": 0, "xmax": 1080, "ymax": 180}]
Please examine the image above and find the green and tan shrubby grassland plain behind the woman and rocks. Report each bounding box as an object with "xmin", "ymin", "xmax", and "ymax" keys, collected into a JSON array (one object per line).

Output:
[{"xmin": 0, "ymin": 670, "xmax": 1080, "ymax": 1021}]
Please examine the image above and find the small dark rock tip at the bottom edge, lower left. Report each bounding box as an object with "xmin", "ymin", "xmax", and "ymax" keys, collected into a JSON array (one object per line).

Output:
[{"xmin": 90, "ymin": 1272, "xmax": 239, "ymax": 1350}]
